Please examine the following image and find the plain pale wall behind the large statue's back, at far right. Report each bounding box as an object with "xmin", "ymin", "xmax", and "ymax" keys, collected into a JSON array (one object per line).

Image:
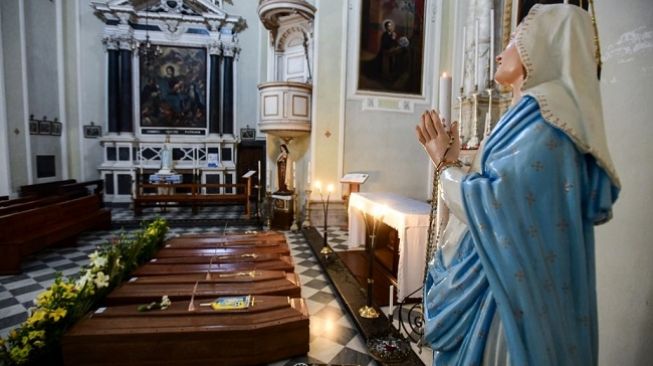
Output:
[{"xmin": 595, "ymin": 0, "xmax": 653, "ymax": 365}]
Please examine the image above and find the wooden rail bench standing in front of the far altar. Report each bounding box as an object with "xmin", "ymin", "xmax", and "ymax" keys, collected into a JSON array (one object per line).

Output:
[{"xmin": 134, "ymin": 178, "xmax": 252, "ymax": 216}]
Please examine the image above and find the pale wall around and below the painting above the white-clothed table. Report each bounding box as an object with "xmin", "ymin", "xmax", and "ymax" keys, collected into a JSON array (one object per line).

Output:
[{"xmin": 344, "ymin": 1, "xmax": 456, "ymax": 200}]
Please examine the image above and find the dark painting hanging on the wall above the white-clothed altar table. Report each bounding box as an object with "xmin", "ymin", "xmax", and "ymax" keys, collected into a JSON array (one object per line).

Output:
[{"xmin": 357, "ymin": 0, "xmax": 426, "ymax": 95}]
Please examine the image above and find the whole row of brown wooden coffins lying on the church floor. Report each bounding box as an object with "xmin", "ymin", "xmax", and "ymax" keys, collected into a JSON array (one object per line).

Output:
[{"xmin": 62, "ymin": 232, "xmax": 309, "ymax": 365}]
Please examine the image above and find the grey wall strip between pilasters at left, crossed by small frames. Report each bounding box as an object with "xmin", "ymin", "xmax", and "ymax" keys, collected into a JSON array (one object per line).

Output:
[{"xmin": 24, "ymin": 1, "xmax": 63, "ymax": 183}]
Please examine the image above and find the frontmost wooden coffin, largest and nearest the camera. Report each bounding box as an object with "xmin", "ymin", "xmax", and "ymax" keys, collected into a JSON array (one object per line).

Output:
[{"xmin": 62, "ymin": 296, "xmax": 309, "ymax": 366}]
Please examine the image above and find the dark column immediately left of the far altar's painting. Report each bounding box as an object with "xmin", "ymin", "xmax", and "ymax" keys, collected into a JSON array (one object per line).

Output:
[{"xmin": 118, "ymin": 39, "xmax": 134, "ymax": 132}]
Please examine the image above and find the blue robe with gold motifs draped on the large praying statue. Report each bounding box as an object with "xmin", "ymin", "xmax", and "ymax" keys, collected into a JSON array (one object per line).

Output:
[{"xmin": 424, "ymin": 96, "xmax": 619, "ymax": 365}]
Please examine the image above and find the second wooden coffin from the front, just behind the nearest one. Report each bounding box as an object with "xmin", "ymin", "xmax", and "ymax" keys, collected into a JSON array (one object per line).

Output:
[{"xmin": 105, "ymin": 271, "xmax": 301, "ymax": 305}]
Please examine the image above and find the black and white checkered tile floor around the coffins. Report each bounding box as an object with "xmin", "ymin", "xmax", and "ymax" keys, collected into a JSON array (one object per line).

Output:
[{"xmin": 0, "ymin": 217, "xmax": 376, "ymax": 366}]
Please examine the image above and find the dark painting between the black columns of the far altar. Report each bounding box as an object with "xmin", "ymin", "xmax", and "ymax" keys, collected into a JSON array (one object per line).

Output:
[{"xmin": 140, "ymin": 46, "xmax": 207, "ymax": 129}]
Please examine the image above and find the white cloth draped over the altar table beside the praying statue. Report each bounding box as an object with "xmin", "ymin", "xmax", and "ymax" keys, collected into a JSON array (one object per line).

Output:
[{"xmin": 348, "ymin": 192, "xmax": 431, "ymax": 301}]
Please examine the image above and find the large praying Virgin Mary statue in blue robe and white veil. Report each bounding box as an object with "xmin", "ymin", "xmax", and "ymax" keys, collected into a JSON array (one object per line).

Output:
[{"xmin": 417, "ymin": 4, "xmax": 620, "ymax": 365}]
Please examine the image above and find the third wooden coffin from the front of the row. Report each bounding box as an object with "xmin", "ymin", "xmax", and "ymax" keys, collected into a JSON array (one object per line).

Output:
[{"xmin": 132, "ymin": 255, "xmax": 295, "ymax": 277}]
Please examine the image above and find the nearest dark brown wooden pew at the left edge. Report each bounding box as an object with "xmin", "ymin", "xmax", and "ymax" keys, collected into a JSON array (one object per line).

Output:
[{"xmin": 0, "ymin": 195, "xmax": 111, "ymax": 274}]
